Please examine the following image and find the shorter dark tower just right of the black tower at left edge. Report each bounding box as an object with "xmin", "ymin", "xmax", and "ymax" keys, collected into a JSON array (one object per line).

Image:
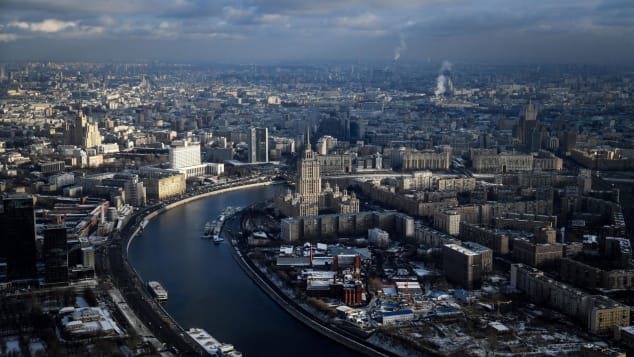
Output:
[{"xmin": 42, "ymin": 226, "xmax": 68, "ymax": 284}]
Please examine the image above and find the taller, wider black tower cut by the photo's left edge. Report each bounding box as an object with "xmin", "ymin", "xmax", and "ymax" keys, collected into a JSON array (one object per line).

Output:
[{"xmin": 0, "ymin": 194, "xmax": 37, "ymax": 280}]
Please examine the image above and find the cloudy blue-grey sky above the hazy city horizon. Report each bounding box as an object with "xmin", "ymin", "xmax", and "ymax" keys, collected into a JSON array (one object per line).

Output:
[{"xmin": 0, "ymin": 0, "xmax": 634, "ymax": 65}]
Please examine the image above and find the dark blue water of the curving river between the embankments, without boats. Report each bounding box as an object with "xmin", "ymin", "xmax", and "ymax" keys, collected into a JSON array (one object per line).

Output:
[{"xmin": 129, "ymin": 186, "xmax": 354, "ymax": 356}]
